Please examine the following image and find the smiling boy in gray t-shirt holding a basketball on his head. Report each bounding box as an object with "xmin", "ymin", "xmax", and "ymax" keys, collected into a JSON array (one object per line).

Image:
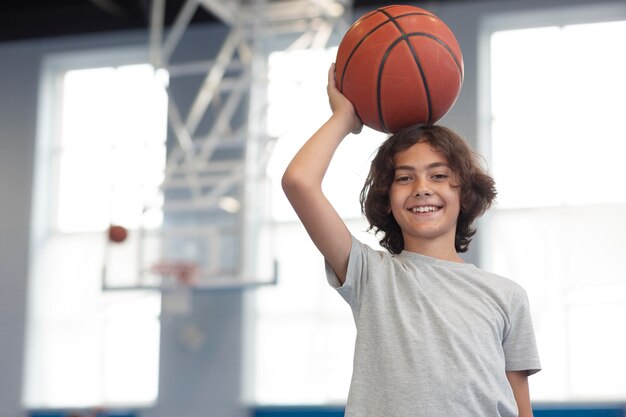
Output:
[{"xmin": 283, "ymin": 66, "xmax": 540, "ymax": 417}]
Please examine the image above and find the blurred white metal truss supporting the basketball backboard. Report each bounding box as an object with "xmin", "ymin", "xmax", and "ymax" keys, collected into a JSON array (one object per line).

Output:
[{"xmin": 105, "ymin": 0, "xmax": 351, "ymax": 288}]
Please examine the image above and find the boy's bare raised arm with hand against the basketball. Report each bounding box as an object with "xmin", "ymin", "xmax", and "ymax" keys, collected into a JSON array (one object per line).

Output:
[{"xmin": 282, "ymin": 65, "xmax": 362, "ymax": 283}]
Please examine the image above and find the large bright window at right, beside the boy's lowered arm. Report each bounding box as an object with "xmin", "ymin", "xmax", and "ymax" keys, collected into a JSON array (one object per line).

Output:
[{"xmin": 483, "ymin": 21, "xmax": 626, "ymax": 401}]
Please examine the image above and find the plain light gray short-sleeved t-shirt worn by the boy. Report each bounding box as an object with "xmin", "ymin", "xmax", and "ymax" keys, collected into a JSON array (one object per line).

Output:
[{"xmin": 326, "ymin": 238, "xmax": 541, "ymax": 417}]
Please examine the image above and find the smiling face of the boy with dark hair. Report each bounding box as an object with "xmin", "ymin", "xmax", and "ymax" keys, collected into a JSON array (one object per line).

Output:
[{"xmin": 389, "ymin": 142, "xmax": 461, "ymax": 252}]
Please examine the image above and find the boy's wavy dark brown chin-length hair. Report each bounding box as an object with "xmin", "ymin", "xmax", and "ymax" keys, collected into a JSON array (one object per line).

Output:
[{"xmin": 360, "ymin": 125, "xmax": 496, "ymax": 254}]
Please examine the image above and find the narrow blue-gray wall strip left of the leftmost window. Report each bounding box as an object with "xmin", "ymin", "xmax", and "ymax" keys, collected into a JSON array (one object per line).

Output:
[{"xmin": 0, "ymin": 38, "xmax": 38, "ymax": 417}]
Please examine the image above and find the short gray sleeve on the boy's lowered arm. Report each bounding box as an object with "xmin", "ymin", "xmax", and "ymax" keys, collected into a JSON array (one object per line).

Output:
[{"xmin": 502, "ymin": 288, "xmax": 541, "ymax": 375}]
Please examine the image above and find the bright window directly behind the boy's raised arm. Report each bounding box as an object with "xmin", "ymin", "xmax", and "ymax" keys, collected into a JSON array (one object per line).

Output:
[{"xmin": 250, "ymin": 48, "xmax": 386, "ymax": 404}]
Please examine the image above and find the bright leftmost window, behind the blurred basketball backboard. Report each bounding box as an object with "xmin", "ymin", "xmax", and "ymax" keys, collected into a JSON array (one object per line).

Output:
[{"xmin": 24, "ymin": 55, "xmax": 167, "ymax": 408}]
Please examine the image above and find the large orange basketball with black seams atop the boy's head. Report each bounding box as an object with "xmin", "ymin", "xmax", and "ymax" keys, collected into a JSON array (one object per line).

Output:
[{"xmin": 335, "ymin": 5, "xmax": 463, "ymax": 133}]
